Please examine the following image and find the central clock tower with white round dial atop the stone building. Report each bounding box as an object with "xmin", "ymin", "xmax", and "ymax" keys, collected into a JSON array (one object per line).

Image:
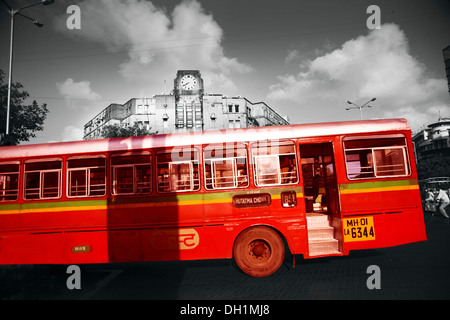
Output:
[{"xmin": 174, "ymin": 70, "xmax": 204, "ymax": 132}]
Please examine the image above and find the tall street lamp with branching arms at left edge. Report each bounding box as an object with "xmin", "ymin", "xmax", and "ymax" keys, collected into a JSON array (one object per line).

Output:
[{"xmin": 1, "ymin": 0, "xmax": 55, "ymax": 135}]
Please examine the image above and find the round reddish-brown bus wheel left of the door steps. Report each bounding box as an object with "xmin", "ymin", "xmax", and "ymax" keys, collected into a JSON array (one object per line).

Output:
[{"xmin": 233, "ymin": 226, "xmax": 284, "ymax": 277}]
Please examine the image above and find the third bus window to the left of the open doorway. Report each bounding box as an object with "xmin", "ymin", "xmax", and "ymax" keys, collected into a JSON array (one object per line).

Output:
[{"xmin": 156, "ymin": 148, "xmax": 200, "ymax": 192}]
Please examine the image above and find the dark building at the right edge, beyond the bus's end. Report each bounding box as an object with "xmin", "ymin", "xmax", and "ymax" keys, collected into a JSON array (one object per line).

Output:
[{"xmin": 413, "ymin": 118, "xmax": 450, "ymax": 161}]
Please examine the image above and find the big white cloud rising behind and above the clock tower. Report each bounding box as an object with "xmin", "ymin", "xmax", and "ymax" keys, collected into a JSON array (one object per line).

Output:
[{"xmin": 55, "ymin": 0, "xmax": 251, "ymax": 88}]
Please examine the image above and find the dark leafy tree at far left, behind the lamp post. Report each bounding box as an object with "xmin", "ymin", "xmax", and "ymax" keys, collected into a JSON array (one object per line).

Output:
[{"xmin": 0, "ymin": 70, "xmax": 49, "ymax": 145}]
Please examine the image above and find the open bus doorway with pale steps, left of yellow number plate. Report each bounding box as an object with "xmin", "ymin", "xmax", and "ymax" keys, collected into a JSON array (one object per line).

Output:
[{"xmin": 300, "ymin": 142, "xmax": 342, "ymax": 256}]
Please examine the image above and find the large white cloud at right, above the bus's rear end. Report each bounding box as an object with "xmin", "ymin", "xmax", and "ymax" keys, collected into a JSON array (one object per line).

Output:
[{"xmin": 268, "ymin": 24, "xmax": 450, "ymax": 131}]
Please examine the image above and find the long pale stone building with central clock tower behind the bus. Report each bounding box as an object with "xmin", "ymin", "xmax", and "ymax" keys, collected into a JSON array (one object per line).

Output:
[{"xmin": 83, "ymin": 70, "xmax": 289, "ymax": 140}]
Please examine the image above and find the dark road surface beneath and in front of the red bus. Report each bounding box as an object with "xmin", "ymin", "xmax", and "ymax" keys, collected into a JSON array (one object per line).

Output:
[{"xmin": 0, "ymin": 214, "xmax": 450, "ymax": 306}]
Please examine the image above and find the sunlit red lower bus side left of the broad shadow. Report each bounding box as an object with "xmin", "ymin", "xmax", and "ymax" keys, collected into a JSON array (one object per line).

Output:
[{"xmin": 0, "ymin": 208, "xmax": 108, "ymax": 264}]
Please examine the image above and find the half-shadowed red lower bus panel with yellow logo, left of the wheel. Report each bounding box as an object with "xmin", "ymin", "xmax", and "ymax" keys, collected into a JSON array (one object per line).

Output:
[{"xmin": 108, "ymin": 200, "xmax": 222, "ymax": 262}]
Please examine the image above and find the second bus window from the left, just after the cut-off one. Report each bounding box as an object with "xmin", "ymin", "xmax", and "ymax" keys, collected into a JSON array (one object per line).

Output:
[{"xmin": 24, "ymin": 160, "xmax": 62, "ymax": 200}]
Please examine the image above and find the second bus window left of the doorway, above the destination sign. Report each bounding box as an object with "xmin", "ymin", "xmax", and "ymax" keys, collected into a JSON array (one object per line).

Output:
[{"xmin": 204, "ymin": 145, "xmax": 249, "ymax": 190}]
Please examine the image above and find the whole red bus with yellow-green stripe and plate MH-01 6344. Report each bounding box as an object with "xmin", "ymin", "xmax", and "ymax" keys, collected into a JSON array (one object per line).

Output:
[{"xmin": 0, "ymin": 119, "xmax": 426, "ymax": 276}]
